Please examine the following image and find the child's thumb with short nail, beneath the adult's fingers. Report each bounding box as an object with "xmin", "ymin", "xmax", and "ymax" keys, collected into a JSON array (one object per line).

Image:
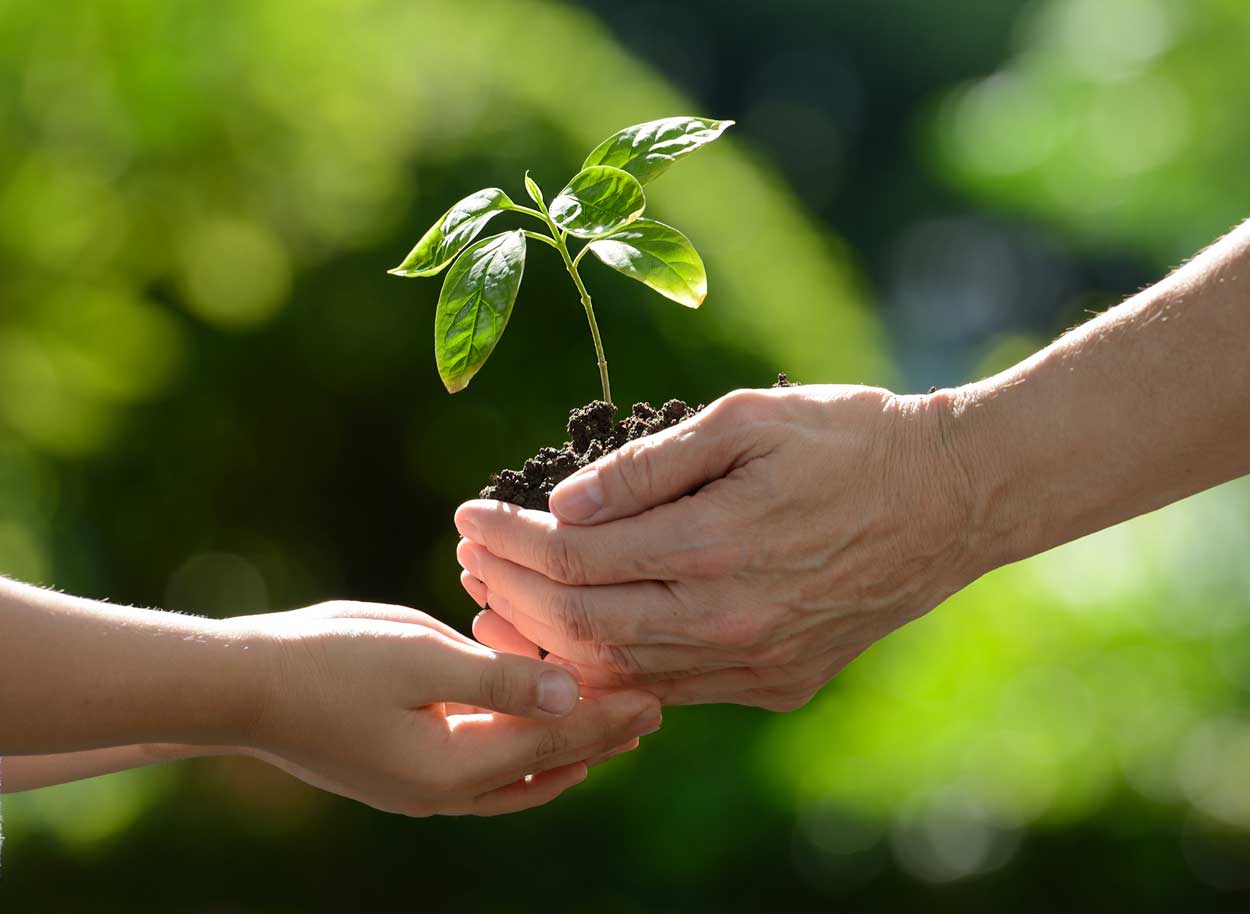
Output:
[{"xmin": 428, "ymin": 641, "xmax": 579, "ymax": 720}]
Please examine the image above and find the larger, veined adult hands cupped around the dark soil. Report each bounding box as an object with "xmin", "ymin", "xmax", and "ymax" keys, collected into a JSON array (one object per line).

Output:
[{"xmin": 456, "ymin": 386, "xmax": 979, "ymax": 710}]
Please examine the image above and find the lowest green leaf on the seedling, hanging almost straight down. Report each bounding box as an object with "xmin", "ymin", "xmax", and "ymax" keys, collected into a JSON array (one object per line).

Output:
[{"xmin": 434, "ymin": 229, "xmax": 525, "ymax": 394}]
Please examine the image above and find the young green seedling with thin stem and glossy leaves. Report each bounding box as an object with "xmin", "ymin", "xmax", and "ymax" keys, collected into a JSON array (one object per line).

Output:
[{"xmin": 390, "ymin": 118, "xmax": 734, "ymax": 403}]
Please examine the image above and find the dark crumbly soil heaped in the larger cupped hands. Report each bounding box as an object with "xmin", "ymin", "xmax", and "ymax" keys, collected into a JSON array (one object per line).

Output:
[{"xmin": 481, "ymin": 374, "xmax": 795, "ymax": 511}]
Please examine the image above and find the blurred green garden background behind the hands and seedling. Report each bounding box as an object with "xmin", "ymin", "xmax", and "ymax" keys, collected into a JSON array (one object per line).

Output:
[{"xmin": 0, "ymin": 0, "xmax": 1250, "ymax": 914}]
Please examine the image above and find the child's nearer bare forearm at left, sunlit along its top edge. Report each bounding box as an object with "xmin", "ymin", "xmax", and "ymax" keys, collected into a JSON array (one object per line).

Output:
[{"xmin": 0, "ymin": 579, "xmax": 268, "ymax": 755}]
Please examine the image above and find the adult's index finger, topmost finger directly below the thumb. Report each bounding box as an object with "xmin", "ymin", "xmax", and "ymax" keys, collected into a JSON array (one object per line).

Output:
[{"xmin": 455, "ymin": 486, "xmax": 741, "ymax": 585}]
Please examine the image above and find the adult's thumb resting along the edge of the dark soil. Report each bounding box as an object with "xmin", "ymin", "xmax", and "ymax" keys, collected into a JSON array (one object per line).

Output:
[{"xmin": 550, "ymin": 391, "xmax": 746, "ymax": 524}]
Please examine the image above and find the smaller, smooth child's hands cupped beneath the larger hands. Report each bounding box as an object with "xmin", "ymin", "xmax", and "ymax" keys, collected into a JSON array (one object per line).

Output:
[{"xmin": 223, "ymin": 603, "xmax": 660, "ymax": 816}]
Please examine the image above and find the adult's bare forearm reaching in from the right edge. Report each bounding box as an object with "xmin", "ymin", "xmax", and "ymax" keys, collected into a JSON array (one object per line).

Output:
[{"xmin": 936, "ymin": 223, "xmax": 1250, "ymax": 570}]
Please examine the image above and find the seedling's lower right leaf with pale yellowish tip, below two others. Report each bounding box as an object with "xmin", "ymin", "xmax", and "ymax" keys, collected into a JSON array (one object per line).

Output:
[{"xmin": 590, "ymin": 219, "xmax": 708, "ymax": 308}]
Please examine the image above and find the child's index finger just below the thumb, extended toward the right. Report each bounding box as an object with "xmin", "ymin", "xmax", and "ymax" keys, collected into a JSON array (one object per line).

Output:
[{"xmin": 449, "ymin": 691, "xmax": 661, "ymax": 793}]
